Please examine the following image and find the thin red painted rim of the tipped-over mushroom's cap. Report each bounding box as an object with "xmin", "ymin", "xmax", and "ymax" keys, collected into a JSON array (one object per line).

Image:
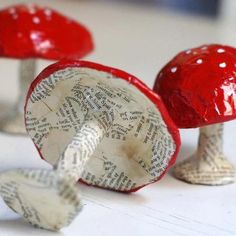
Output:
[{"xmin": 25, "ymin": 60, "xmax": 180, "ymax": 192}]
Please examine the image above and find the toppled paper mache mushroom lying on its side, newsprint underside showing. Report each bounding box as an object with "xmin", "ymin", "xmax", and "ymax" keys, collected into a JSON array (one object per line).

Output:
[{"xmin": 0, "ymin": 60, "xmax": 180, "ymax": 230}]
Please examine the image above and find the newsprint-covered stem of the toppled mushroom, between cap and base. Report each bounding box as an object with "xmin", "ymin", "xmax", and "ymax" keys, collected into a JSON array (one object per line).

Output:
[{"xmin": 56, "ymin": 112, "xmax": 114, "ymax": 182}]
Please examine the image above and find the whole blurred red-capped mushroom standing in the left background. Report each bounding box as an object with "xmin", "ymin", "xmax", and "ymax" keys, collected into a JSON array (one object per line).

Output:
[{"xmin": 0, "ymin": 4, "xmax": 93, "ymax": 134}]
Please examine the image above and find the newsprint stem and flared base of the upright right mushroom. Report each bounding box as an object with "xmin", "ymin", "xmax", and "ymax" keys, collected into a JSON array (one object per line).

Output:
[{"xmin": 174, "ymin": 123, "xmax": 235, "ymax": 185}]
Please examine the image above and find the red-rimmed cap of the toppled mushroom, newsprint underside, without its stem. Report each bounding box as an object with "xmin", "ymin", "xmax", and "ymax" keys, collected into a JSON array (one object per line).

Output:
[{"xmin": 25, "ymin": 61, "xmax": 180, "ymax": 192}]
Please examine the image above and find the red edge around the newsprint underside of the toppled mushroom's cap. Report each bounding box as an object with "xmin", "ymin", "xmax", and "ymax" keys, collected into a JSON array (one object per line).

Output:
[{"xmin": 25, "ymin": 60, "xmax": 180, "ymax": 192}]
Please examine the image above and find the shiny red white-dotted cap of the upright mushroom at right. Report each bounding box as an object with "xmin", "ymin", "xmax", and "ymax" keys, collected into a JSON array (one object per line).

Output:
[{"xmin": 154, "ymin": 44, "xmax": 236, "ymax": 128}]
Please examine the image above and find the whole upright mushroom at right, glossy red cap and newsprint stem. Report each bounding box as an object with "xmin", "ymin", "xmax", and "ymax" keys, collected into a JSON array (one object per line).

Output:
[{"xmin": 154, "ymin": 44, "xmax": 236, "ymax": 185}]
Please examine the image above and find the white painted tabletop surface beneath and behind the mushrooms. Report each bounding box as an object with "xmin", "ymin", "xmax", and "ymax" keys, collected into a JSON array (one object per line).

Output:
[{"xmin": 0, "ymin": 0, "xmax": 236, "ymax": 236}]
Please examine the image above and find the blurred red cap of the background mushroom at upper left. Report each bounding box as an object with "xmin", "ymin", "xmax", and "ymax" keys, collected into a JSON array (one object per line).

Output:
[{"xmin": 0, "ymin": 5, "xmax": 93, "ymax": 60}]
